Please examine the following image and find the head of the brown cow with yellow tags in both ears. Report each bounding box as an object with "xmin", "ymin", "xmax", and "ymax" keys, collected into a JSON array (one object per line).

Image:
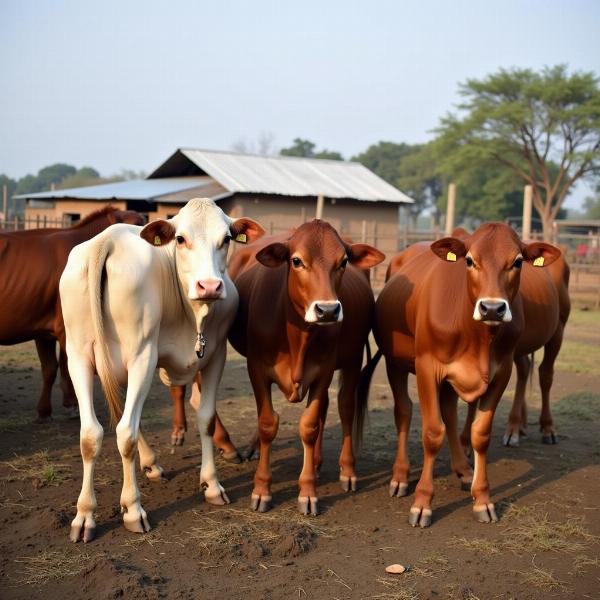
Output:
[{"xmin": 431, "ymin": 223, "xmax": 560, "ymax": 325}]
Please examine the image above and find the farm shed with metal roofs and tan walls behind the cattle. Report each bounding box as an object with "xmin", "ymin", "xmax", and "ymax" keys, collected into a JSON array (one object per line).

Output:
[{"xmin": 20, "ymin": 148, "xmax": 412, "ymax": 282}]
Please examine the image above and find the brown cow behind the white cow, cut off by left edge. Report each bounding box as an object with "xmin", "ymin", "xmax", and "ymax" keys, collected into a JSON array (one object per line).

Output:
[{"xmin": 0, "ymin": 206, "xmax": 144, "ymax": 421}]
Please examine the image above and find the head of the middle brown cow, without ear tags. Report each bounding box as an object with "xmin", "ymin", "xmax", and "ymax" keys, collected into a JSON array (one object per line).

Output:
[{"xmin": 256, "ymin": 220, "xmax": 385, "ymax": 325}]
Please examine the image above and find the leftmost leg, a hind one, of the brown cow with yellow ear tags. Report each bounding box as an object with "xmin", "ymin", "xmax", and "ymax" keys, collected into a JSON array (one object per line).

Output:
[{"xmin": 385, "ymin": 358, "xmax": 412, "ymax": 498}]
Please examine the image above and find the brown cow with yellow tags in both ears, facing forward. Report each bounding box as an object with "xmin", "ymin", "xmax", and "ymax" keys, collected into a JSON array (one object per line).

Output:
[{"xmin": 366, "ymin": 223, "xmax": 560, "ymax": 527}]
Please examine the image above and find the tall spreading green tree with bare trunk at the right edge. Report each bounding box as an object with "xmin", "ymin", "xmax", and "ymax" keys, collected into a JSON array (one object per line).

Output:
[{"xmin": 436, "ymin": 65, "xmax": 600, "ymax": 239}]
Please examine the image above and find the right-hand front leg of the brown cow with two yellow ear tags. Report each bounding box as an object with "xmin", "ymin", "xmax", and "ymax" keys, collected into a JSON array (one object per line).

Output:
[{"xmin": 471, "ymin": 361, "xmax": 512, "ymax": 523}]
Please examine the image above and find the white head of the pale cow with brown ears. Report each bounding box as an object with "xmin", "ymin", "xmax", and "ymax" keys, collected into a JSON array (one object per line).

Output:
[{"xmin": 140, "ymin": 198, "xmax": 264, "ymax": 302}]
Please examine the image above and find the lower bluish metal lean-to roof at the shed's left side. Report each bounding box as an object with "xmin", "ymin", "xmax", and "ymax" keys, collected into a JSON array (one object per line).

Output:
[{"xmin": 15, "ymin": 176, "xmax": 212, "ymax": 200}]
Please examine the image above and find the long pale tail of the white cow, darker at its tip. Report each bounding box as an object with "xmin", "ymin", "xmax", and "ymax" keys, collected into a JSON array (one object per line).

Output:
[{"xmin": 88, "ymin": 236, "xmax": 123, "ymax": 426}]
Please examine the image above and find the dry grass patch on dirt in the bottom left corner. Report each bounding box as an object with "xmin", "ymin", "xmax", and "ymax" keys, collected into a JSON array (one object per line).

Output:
[{"xmin": 15, "ymin": 550, "xmax": 103, "ymax": 585}]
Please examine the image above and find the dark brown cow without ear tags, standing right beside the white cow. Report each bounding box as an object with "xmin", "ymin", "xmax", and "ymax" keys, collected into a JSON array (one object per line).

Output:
[{"xmin": 229, "ymin": 220, "xmax": 384, "ymax": 515}]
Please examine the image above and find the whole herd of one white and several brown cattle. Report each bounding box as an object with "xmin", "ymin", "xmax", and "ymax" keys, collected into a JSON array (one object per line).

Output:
[{"xmin": 0, "ymin": 199, "xmax": 570, "ymax": 542}]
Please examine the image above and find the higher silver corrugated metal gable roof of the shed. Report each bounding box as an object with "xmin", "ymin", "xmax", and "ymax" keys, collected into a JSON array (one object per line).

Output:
[{"xmin": 149, "ymin": 148, "xmax": 413, "ymax": 203}]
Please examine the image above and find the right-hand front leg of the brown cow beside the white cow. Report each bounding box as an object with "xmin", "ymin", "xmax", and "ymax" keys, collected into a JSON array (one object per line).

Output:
[{"xmin": 298, "ymin": 386, "xmax": 327, "ymax": 516}]
